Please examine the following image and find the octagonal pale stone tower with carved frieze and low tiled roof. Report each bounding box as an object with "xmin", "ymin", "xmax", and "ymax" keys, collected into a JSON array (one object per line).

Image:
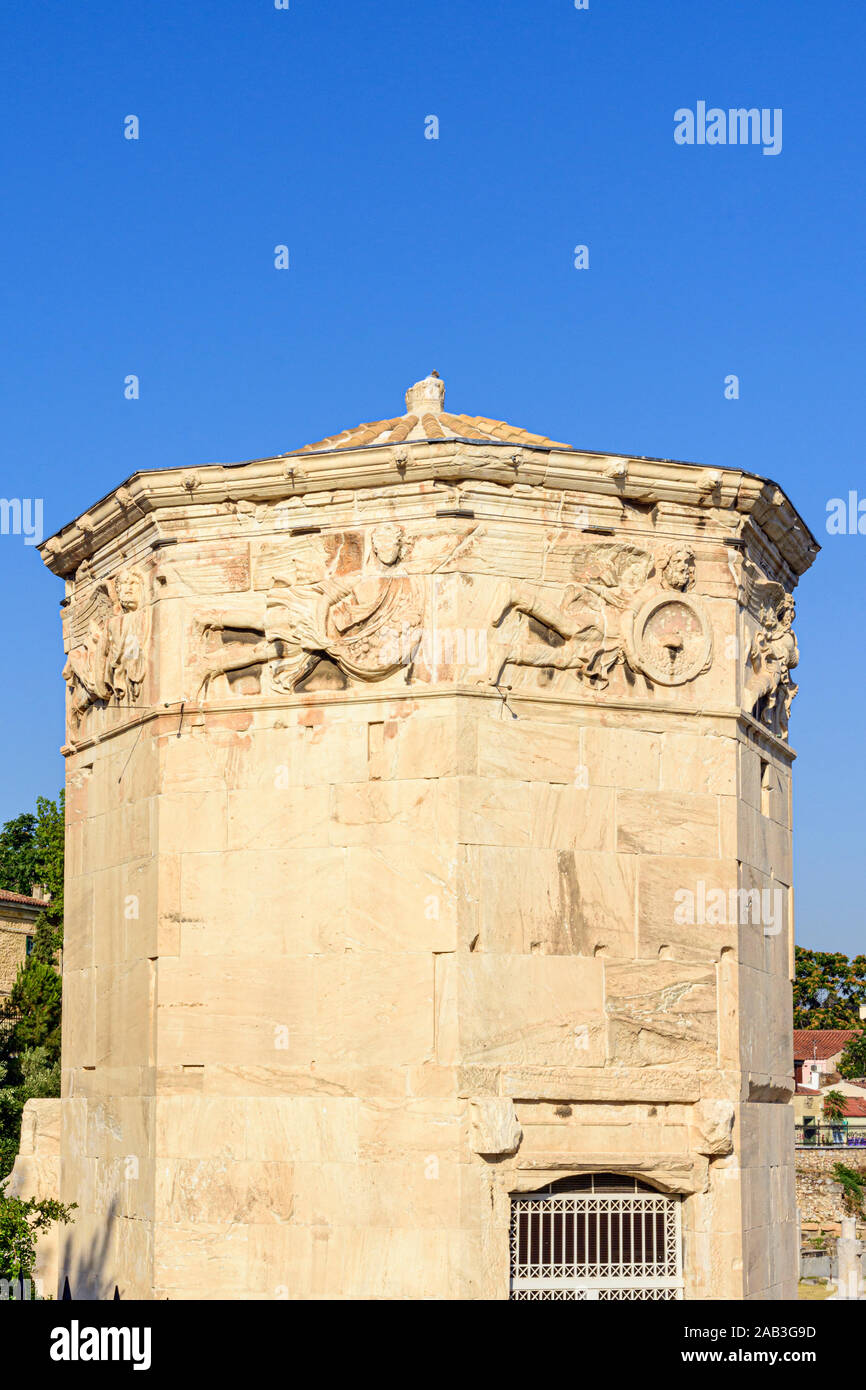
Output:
[{"xmin": 42, "ymin": 374, "xmax": 817, "ymax": 1300}]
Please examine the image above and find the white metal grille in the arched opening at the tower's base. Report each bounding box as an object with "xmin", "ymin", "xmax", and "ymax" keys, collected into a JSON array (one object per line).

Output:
[{"xmin": 510, "ymin": 1173, "xmax": 683, "ymax": 1301}]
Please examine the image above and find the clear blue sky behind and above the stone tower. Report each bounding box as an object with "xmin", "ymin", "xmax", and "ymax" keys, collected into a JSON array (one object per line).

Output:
[{"xmin": 0, "ymin": 0, "xmax": 866, "ymax": 954}]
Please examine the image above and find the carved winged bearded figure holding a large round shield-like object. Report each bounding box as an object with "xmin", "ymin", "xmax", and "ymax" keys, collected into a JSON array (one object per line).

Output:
[{"xmin": 493, "ymin": 543, "xmax": 713, "ymax": 689}]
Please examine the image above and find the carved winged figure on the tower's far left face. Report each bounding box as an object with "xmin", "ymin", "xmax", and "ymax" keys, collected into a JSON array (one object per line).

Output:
[{"xmin": 63, "ymin": 564, "xmax": 150, "ymax": 733}]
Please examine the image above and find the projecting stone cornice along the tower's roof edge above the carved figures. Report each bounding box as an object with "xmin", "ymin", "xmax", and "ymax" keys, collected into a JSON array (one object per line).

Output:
[{"xmin": 39, "ymin": 439, "xmax": 820, "ymax": 582}]
